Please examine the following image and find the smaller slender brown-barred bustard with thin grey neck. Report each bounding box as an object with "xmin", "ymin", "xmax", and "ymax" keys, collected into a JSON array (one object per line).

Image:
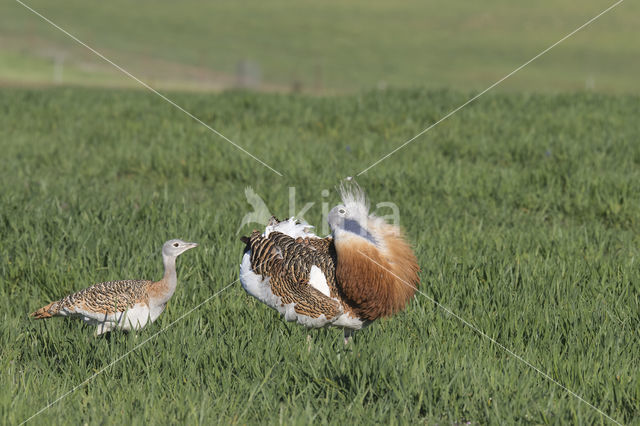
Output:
[{"xmin": 31, "ymin": 240, "xmax": 198, "ymax": 335}]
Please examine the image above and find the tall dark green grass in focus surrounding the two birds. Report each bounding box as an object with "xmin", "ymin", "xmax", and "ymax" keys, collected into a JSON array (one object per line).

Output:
[{"xmin": 0, "ymin": 85, "xmax": 640, "ymax": 424}]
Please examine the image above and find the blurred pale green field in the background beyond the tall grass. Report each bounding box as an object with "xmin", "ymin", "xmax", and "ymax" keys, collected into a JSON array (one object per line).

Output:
[{"xmin": 0, "ymin": 0, "xmax": 640, "ymax": 93}]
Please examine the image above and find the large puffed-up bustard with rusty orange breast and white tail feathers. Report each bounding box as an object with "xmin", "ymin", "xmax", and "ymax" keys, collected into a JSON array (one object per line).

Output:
[{"xmin": 240, "ymin": 184, "xmax": 420, "ymax": 343}]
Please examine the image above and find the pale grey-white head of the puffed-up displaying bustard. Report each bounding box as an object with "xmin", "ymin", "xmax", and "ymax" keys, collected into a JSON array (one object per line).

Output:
[{"xmin": 328, "ymin": 182, "xmax": 381, "ymax": 246}]
